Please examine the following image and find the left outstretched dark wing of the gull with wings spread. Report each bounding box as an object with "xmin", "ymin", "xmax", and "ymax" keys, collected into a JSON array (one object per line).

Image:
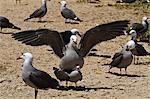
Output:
[{"xmin": 12, "ymin": 29, "xmax": 64, "ymax": 58}]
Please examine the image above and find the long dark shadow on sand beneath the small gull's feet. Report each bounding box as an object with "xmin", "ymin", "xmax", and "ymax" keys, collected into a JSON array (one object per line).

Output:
[{"xmin": 58, "ymin": 86, "xmax": 112, "ymax": 91}]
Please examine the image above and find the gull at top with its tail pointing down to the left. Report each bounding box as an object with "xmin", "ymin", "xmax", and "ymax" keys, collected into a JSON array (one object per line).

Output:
[{"xmin": 24, "ymin": 0, "xmax": 50, "ymax": 22}]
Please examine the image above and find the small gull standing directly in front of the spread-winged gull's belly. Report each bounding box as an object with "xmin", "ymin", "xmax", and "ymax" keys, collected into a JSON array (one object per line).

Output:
[{"xmin": 53, "ymin": 66, "xmax": 82, "ymax": 87}]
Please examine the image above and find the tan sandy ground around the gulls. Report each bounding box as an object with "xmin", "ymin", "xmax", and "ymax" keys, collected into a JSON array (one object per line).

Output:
[{"xmin": 0, "ymin": 0, "xmax": 150, "ymax": 99}]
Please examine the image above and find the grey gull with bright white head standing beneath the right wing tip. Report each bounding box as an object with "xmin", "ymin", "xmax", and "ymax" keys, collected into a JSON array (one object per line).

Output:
[{"xmin": 109, "ymin": 40, "xmax": 135, "ymax": 74}]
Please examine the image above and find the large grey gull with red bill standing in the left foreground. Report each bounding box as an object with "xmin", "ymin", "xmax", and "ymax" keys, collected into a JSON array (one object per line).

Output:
[{"xmin": 17, "ymin": 53, "xmax": 59, "ymax": 99}]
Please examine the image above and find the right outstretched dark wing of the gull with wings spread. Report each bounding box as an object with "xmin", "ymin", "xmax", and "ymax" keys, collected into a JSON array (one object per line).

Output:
[{"xmin": 80, "ymin": 20, "xmax": 129, "ymax": 57}]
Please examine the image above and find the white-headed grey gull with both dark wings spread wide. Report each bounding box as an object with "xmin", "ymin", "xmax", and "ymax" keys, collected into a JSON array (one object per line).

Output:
[{"xmin": 12, "ymin": 20, "xmax": 129, "ymax": 70}]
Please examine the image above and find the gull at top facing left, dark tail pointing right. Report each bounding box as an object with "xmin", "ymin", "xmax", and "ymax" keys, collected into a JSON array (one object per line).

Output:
[{"xmin": 60, "ymin": 1, "xmax": 83, "ymax": 23}]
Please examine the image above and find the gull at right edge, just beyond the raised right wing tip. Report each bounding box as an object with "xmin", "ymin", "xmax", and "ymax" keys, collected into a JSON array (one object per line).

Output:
[{"xmin": 129, "ymin": 16, "xmax": 149, "ymax": 37}]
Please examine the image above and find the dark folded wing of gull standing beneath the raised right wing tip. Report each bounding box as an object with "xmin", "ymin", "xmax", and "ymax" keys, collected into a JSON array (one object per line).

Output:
[{"xmin": 110, "ymin": 53, "xmax": 123, "ymax": 66}]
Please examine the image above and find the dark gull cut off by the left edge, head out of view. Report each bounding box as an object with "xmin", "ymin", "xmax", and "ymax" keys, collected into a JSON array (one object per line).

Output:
[{"xmin": 0, "ymin": 16, "xmax": 21, "ymax": 31}]
